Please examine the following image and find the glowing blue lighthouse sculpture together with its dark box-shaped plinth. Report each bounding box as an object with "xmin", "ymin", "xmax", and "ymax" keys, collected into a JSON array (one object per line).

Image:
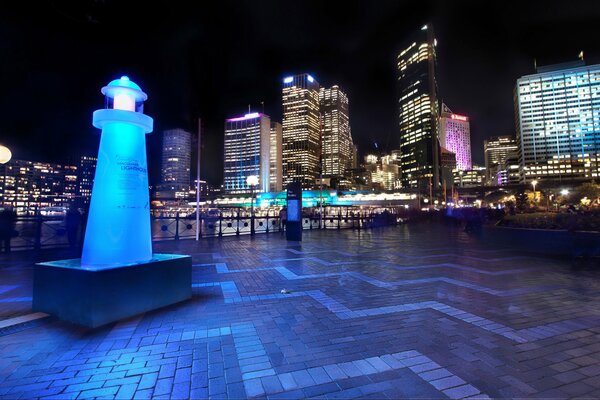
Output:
[{"xmin": 33, "ymin": 76, "xmax": 192, "ymax": 327}]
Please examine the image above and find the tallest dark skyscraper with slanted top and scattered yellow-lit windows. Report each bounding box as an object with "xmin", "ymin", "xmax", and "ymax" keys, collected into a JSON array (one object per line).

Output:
[{"xmin": 397, "ymin": 25, "xmax": 440, "ymax": 189}]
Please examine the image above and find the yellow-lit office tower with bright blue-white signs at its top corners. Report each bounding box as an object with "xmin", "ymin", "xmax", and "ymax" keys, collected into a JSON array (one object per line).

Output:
[{"xmin": 283, "ymin": 74, "xmax": 321, "ymax": 188}]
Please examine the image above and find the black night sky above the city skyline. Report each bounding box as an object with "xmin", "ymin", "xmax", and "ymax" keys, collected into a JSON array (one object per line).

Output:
[{"xmin": 0, "ymin": 0, "xmax": 600, "ymax": 184}]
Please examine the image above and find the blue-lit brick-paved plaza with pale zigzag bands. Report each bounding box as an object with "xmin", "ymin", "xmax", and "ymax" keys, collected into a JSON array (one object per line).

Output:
[{"xmin": 0, "ymin": 223, "xmax": 600, "ymax": 399}]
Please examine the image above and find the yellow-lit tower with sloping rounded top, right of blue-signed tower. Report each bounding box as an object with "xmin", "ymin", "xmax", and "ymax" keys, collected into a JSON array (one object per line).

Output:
[{"xmin": 319, "ymin": 85, "xmax": 354, "ymax": 177}]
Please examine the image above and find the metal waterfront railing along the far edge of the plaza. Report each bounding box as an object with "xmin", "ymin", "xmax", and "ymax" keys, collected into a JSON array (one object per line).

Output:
[{"xmin": 2, "ymin": 208, "xmax": 399, "ymax": 251}]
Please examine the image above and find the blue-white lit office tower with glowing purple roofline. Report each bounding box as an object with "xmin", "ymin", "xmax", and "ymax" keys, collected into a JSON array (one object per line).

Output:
[{"xmin": 223, "ymin": 113, "xmax": 271, "ymax": 194}]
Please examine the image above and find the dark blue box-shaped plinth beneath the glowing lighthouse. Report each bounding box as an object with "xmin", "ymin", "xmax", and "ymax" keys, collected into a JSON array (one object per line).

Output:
[{"xmin": 33, "ymin": 254, "xmax": 192, "ymax": 328}]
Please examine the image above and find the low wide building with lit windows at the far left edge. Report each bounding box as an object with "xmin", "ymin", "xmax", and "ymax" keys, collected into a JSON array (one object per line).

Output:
[{"xmin": 0, "ymin": 160, "xmax": 78, "ymax": 214}]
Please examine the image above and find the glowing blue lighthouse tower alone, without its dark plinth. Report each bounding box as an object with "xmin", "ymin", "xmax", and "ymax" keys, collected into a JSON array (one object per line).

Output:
[{"xmin": 81, "ymin": 76, "xmax": 153, "ymax": 267}]
